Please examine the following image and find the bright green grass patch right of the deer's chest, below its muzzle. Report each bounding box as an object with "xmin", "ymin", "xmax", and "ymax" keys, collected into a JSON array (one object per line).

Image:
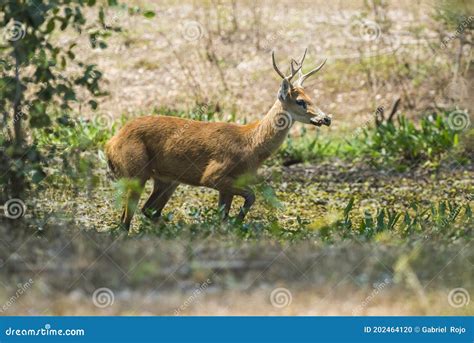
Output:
[{"xmin": 277, "ymin": 112, "xmax": 470, "ymax": 171}]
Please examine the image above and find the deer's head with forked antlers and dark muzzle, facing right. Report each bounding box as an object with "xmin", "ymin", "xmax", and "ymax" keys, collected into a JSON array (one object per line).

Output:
[{"xmin": 272, "ymin": 49, "xmax": 331, "ymax": 126}]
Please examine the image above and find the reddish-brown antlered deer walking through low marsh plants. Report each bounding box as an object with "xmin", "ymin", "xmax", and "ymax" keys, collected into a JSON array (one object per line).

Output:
[{"xmin": 106, "ymin": 49, "xmax": 331, "ymax": 230}]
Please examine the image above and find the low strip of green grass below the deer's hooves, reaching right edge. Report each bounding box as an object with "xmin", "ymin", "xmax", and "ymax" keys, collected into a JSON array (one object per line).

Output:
[{"xmin": 124, "ymin": 199, "xmax": 473, "ymax": 244}]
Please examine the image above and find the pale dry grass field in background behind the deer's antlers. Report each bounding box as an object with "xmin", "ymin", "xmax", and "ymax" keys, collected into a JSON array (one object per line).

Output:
[{"xmin": 60, "ymin": 0, "xmax": 472, "ymax": 130}]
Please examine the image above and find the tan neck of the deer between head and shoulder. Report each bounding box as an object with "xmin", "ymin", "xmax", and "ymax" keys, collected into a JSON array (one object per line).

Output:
[{"xmin": 251, "ymin": 100, "xmax": 293, "ymax": 159}]
